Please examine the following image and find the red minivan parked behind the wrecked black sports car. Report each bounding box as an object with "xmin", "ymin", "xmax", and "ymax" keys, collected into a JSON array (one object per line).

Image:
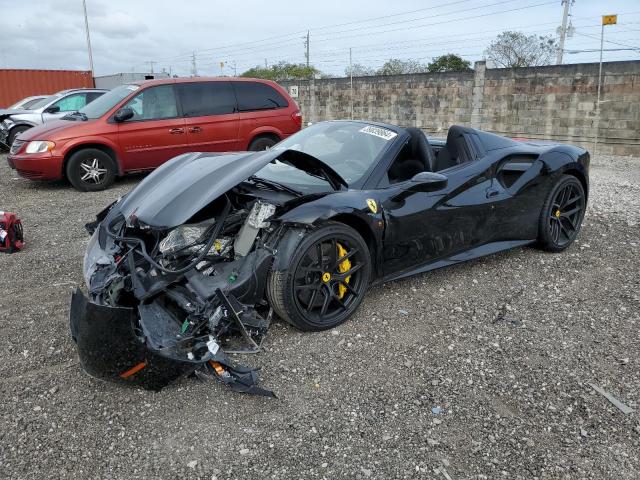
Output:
[{"xmin": 7, "ymin": 77, "xmax": 302, "ymax": 191}]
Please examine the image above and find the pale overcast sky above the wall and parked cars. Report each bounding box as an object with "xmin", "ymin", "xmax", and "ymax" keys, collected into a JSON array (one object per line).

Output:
[{"xmin": 0, "ymin": 0, "xmax": 640, "ymax": 76}]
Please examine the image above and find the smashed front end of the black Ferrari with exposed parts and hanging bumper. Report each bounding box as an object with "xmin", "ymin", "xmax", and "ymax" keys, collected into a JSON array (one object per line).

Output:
[{"xmin": 70, "ymin": 189, "xmax": 296, "ymax": 396}]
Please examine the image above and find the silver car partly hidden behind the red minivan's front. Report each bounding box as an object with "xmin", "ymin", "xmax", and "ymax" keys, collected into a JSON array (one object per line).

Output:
[{"xmin": 0, "ymin": 88, "xmax": 108, "ymax": 147}]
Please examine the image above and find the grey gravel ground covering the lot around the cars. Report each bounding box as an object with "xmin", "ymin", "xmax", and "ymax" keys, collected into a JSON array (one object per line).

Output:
[{"xmin": 0, "ymin": 153, "xmax": 640, "ymax": 480}]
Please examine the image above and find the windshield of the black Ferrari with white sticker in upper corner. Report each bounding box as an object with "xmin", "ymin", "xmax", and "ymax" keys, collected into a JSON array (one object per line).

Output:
[{"xmin": 257, "ymin": 122, "xmax": 398, "ymax": 192}]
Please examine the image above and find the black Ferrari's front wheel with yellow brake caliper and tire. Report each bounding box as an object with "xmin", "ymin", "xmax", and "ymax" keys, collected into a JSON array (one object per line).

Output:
[{"xmin": 267, "ymin": 223, "xmax": 371, "ymax": 331}]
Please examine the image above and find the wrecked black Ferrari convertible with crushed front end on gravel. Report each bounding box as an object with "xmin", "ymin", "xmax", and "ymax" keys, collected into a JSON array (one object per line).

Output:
[{"xmin": 71, "ymin": 121, "xmax": 589, "ymax": 394}]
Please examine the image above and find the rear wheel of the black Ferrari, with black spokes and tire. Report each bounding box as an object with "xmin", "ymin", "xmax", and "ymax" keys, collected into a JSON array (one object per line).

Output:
[{"xmin": 538, "ymin": 175, "xmax": 587, "ymax": 252}]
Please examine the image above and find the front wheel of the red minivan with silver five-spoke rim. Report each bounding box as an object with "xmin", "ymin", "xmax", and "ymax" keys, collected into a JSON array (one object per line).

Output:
[{"xmin": 66, "ymin": 148, "xmax": 117, "ymax": 192}]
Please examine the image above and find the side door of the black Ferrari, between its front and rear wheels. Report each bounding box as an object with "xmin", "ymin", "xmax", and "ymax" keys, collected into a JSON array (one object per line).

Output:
[{"xmin": 382, "ymin": 152, "xmax": 495, "ymax": 276}]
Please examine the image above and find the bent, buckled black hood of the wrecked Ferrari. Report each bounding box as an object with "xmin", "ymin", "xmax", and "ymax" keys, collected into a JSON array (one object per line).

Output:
[{"xmin": 118, "ymin": 150, "xmax": 347, "ymax": 229}]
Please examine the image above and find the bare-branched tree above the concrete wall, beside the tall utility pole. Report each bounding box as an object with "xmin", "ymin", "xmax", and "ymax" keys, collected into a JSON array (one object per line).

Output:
[{"xmin": 485, "ymin": 32, "xmax": 558, "ymax": 68}]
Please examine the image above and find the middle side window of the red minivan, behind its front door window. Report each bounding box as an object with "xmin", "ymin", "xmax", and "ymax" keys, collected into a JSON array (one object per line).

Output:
[{"xmin": 176, "ymin": 82, "xmax": 236, "ymax": 117}]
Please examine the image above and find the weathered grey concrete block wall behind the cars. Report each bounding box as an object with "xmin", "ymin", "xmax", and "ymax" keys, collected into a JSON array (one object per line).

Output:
[{"xmin": 281, "ymin": 61, "xmax": 640, "ymax": 156}]
